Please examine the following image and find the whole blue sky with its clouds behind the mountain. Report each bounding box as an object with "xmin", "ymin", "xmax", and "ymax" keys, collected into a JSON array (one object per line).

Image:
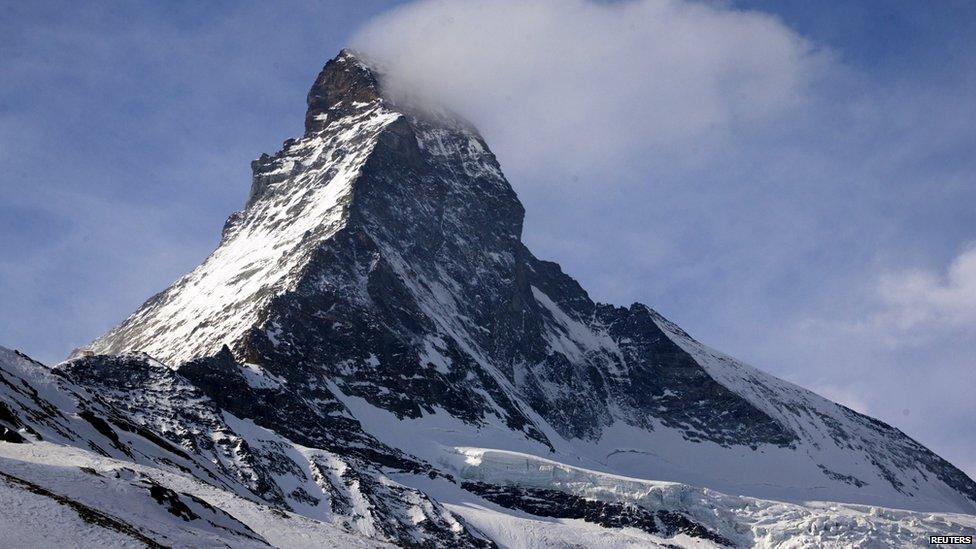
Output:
[{"xmin": 0, "ymin": 0, "xmax": 976, "ymax": 477}]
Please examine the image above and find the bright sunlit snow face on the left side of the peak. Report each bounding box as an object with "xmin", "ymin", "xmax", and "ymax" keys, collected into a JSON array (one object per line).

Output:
[{"xmin": 89, "ymin": 104, "xmax": 401, "ymax": 366}]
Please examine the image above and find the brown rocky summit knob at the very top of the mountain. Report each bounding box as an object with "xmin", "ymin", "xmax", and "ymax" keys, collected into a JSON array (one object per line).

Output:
[{"xmin": 305, "ymin": 48, "xmax": 380, "ymax": 134}]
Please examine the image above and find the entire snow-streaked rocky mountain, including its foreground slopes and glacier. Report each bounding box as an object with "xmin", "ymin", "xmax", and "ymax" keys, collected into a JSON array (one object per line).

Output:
[{"xmin": 0, "ymin": 51, "xmax": 976, "ymax": 547}]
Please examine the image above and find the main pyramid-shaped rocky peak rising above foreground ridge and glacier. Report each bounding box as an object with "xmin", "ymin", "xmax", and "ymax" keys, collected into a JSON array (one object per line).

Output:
[{"xmin": 82, "ymin": 52, "xmax": 976, "ymax": 509}]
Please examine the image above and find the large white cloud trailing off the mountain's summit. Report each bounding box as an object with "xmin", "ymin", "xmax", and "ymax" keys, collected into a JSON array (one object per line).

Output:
[{"xmin": 352, "ymin": 0, "xmax": 829, "ymax": 178}]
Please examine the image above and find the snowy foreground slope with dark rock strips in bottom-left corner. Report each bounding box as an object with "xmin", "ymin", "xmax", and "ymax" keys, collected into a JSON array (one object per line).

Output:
[{"xmin": 0, "ymin": 442, "xmax": 393, "ymax": 548}]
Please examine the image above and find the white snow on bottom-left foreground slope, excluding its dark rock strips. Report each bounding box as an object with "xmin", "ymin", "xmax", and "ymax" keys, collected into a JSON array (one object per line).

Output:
[{"xmin": 0, "ymin": 436, "xmax": 392, "ymax": 548}]
